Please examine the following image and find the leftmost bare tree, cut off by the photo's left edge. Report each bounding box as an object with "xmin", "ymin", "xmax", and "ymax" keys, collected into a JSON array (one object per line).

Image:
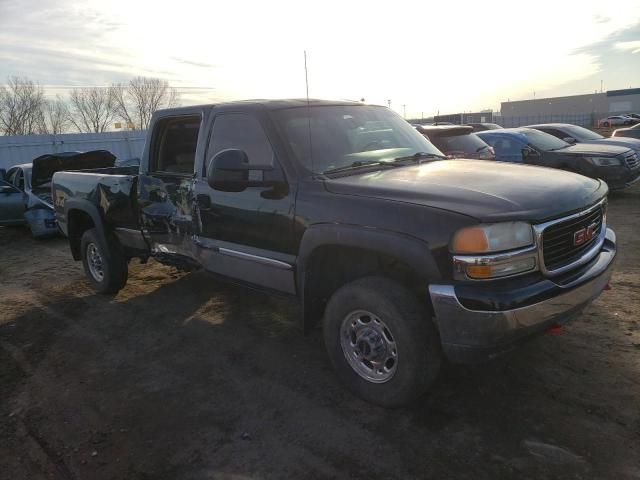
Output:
[{"xmin": 0, "ymin": 77, "xmax": 45, "ymax": 135}]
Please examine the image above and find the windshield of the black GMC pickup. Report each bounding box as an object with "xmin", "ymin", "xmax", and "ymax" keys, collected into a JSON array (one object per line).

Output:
[{"xmin": 274, "ymin": 105, "xmax": 442, "ymax": 173}]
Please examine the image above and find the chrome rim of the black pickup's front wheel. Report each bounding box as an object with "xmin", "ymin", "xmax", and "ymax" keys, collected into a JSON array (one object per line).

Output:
[{"xmin": 340, "ymin": 310, "xmax": 398, "ymax": 383}]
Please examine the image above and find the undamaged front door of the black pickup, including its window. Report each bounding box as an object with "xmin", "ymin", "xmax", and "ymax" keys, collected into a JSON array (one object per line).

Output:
[{"xmin": 194, "ymin": 112, "xmax": 295, "ymax": 293}]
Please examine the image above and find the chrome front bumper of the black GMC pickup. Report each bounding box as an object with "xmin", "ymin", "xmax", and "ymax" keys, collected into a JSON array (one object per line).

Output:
[{"xmin": 429, "ymin": 229, "xmax": 616, "ymax": 363}]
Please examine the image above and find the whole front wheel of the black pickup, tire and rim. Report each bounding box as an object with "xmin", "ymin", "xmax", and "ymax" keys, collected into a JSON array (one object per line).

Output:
[{"xmin": 323, "ymin": 277, "xmax": 442, "ymax": 407}]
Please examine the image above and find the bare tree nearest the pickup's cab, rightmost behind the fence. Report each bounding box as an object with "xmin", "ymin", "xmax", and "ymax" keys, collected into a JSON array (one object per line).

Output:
[{"xmin": 111, "ymin": 77, "xmax": 178, "ymax": 130}]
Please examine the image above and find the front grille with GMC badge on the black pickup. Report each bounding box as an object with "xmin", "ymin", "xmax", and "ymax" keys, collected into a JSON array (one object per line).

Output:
[{"xmin": 542, "ymin": 204, "xmax": 606, "ymax": 270}]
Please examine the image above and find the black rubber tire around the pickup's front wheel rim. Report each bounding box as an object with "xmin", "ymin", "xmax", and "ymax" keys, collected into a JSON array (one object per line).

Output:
[{"xmin": 323, "ymin": 277, "xmax": 442, "ymax": 407}]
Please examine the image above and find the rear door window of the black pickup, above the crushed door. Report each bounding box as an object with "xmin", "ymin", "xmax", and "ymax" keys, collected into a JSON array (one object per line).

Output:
[{"xmin": 150, "ymin": 116, "xmax": 200, "ymax": 174}]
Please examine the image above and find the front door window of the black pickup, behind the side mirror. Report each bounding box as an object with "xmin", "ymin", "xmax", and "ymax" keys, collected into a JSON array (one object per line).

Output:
[{"xmin": 205, "ymin": 113, "xmax": 275, "ymax": 172}]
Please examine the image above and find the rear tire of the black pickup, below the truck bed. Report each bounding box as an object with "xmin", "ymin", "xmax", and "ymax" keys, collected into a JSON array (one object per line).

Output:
[{"xmin": 80, "ymin": 228, "xmax": 129, "ymax": 294}]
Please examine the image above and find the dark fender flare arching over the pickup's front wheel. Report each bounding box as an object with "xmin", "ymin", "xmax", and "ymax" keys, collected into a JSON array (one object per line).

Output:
[{"xmin": 296, "ymin": 223, "xmax": 442, "ymax": 332}]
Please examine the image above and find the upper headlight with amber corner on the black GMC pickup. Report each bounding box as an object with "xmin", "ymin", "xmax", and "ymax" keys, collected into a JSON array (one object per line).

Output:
[{"xmin": 451, "ymin": 222, "xmax": 533, "ymax": 254}]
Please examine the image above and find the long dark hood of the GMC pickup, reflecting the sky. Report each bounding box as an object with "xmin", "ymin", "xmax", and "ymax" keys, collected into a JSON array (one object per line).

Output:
[{"xmin": 325, "ymin": 160, "xmax": 608, "ymax": 223}]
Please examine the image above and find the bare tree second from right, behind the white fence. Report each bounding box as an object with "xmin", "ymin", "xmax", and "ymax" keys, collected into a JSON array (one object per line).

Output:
[{"xmin": 68, "ymin": 87, "xmax": 116, "ymax": 133}]
